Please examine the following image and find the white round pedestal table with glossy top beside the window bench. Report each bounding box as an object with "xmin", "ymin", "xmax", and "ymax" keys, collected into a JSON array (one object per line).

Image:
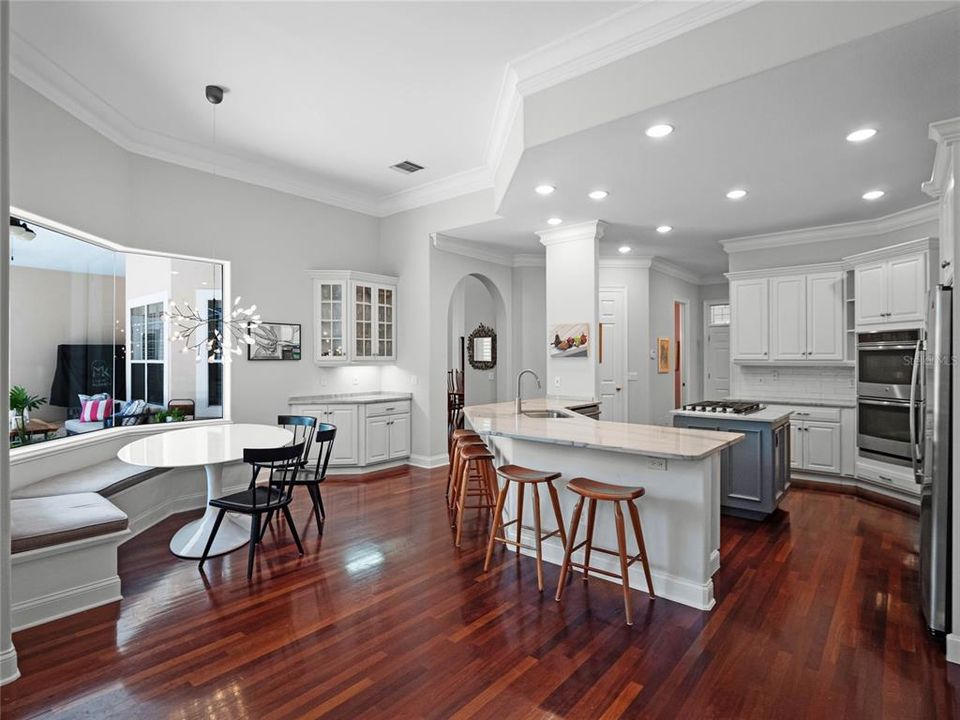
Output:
[{"xmin": 117, "ymin": 424, "xmax": 293, "ymax": 559}]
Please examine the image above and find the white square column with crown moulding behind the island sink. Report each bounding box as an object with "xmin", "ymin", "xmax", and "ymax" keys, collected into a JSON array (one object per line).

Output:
[{"xmin": 537, "ymin": 220, "xmax": 604, "ymax": 400}]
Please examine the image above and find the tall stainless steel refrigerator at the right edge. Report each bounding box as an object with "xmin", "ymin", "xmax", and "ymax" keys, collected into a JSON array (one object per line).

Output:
[{"xmin": 911, "ymin": 285, "xmax": 955, "ymax": 632}]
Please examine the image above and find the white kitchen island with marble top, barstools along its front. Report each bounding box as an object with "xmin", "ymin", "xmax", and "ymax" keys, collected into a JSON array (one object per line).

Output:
[{"xmin": 465, "ymin": 398, "xmax": 743, "ymax": 610}]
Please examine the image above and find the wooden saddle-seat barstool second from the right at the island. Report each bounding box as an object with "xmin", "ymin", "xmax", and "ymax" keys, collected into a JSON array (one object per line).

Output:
[{"xmin": 483, "ymin": 465, "xmax": 567, "ymax": 592}]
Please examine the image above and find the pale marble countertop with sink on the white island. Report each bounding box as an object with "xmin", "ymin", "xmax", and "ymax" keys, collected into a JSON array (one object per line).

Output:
[{"xmin": 464, "ymin": 398, "xmax": 743, "ymax": 460}]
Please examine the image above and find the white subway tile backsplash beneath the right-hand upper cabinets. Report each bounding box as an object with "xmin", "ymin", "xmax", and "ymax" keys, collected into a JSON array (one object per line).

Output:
[{"xmin": 732, "ymin": 365, "xmax": 857, "ymax": 402}]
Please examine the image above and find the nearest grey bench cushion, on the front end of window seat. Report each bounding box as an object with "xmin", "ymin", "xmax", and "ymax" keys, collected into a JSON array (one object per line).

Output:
[{"xmin": 10, "ymin": 493, "xmax": 127, "ymax": 553}]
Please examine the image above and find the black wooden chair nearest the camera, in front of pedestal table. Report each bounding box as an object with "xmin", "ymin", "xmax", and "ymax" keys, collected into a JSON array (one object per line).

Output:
[{"xmin": 200, "ymin": 443, "xmax": 303, "ymax": 580}]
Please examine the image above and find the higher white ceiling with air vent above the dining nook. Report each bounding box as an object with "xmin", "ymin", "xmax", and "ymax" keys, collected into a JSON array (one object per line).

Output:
[{"xmin": 11, "ymin": 2, "xmax": 627, "ymax": 207}]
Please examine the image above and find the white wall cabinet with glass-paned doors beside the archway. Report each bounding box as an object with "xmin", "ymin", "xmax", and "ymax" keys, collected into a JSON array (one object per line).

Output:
[{"xmin": 308, "ymin": 270, "xmax": 397, "ymax": 365}]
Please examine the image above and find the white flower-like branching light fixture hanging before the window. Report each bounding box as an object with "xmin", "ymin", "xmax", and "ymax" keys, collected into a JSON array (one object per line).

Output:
[{"xmin": 163, "ymin": 295, "xmax": 262, "ymax": 363}]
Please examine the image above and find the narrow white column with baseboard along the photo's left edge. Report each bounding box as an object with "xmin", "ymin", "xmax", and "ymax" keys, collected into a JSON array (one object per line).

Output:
[{"xmin": 0, "ymin": 2, "xmax": 20, "ymax": 685}]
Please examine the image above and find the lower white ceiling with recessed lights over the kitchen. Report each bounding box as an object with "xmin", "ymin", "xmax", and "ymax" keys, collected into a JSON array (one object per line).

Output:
[{"xmin": 446, "ymin": 9, "xmax": 960, "ymax": 275}]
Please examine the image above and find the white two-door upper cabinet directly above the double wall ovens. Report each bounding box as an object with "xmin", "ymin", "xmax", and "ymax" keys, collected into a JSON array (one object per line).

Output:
[{"xmin": 854, "ymin": 246, "xmax": 931, "ymax": 326}]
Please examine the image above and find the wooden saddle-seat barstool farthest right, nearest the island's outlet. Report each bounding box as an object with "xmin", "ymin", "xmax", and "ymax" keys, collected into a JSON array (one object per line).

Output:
[{"xmin": 556, "ymin": 478, "xmax": 656, "ymax": 625}]
